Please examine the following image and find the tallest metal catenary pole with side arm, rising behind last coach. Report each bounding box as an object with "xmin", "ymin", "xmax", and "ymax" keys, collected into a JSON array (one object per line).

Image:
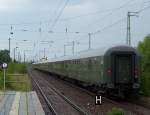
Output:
[{"xmin": 126, "ymin": 12, "xmax": 138, "ymax": 45}]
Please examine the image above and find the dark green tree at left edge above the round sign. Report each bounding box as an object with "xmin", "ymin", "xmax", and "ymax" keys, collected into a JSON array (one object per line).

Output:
[{"xmin": 0, "ymin": 50, "xmax": 11, "ymax": 63}]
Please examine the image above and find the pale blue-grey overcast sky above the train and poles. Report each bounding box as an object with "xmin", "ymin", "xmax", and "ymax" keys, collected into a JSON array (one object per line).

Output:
[{"xmin": 0, "ymin": 0, "xmax": 150, "ymax": 62}]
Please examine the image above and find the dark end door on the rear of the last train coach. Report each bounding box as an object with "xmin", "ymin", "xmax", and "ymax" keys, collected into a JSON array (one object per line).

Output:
[{"xmin": 114, "ymin": 54, "xmax": 133, "ymax": 83}]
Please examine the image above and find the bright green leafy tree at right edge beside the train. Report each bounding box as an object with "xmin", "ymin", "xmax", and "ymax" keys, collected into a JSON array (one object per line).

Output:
[{"xmin": 138, "ymin": 35, "xmax": 150, "ymax": 96}]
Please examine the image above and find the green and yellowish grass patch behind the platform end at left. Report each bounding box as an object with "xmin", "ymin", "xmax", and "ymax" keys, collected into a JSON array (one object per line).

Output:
[{"xmin": 0, "ymin": 62, "xmax": 31, "ymax": 91}]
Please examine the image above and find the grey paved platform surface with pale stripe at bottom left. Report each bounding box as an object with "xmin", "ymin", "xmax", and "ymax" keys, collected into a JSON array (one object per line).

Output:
[{"xmin": 0, "ymin": 91, "xmax": 45, "ymax": 115}]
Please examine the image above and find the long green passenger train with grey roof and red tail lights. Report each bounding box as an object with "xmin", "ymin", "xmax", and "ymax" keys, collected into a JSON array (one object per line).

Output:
[{"xmin": 33, "ymin": 45, "xmax": 140, "ymax": 98}]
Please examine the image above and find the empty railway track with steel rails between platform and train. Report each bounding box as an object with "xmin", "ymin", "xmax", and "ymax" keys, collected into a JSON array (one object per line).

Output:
[{"xmin": 30, "ymin": 69, "xmax": 89, "ymax": 115}]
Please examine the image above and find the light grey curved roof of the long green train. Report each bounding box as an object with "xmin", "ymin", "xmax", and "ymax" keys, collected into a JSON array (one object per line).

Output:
[{"xmin": 35, "ymin": 45, "xmax": 137, "ymax": 64}]
